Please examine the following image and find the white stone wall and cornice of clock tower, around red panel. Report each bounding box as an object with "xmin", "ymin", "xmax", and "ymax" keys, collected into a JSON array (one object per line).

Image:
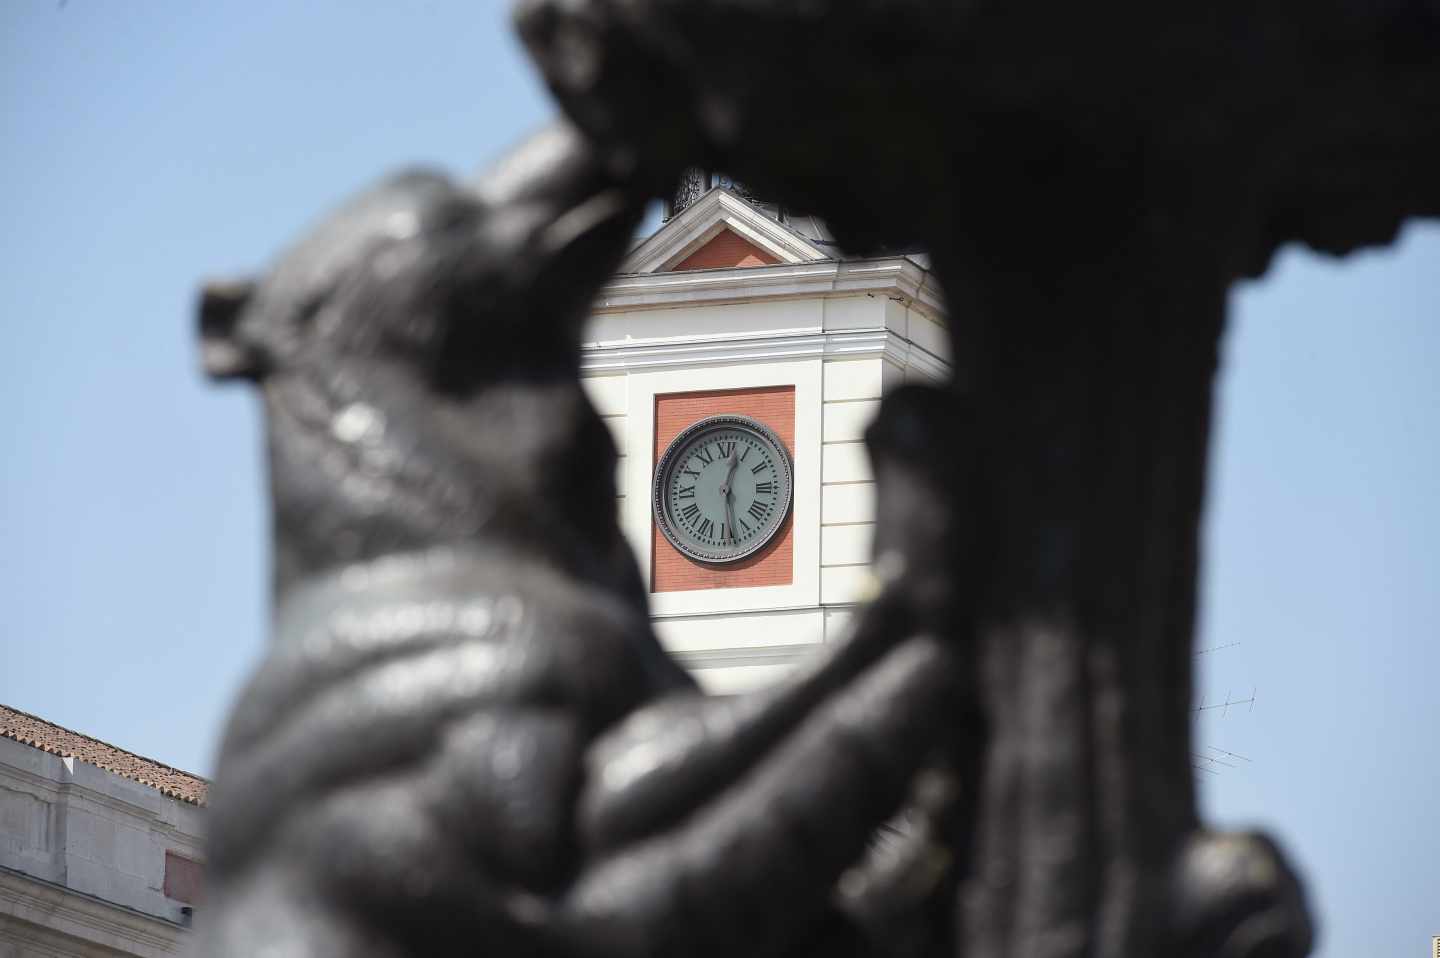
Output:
[{"xmin": 582, "ymin": 261, "xmax": 949, "ymax": 693}]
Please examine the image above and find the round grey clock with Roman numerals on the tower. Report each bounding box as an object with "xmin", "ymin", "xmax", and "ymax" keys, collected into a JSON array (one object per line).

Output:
[{"xmin": 652, "ymin": 415, "xmax": 795, "ymax": 562}]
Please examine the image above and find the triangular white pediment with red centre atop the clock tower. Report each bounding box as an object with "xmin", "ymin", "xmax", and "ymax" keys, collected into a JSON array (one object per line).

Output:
[{"xmin": 621, "ymin": 189, "xmax": 831, "ymax": 272}]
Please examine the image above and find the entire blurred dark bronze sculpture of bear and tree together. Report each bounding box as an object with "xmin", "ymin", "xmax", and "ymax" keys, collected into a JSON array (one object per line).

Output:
[{"xmin": 200, "ymin": 0, "xmax": 1440, "ymax": 958}]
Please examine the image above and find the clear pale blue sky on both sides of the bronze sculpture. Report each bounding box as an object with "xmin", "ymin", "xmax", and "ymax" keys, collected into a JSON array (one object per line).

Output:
[{"xmin": 0, "ymin": 0, "xmax": 1440, "ymax": 958}]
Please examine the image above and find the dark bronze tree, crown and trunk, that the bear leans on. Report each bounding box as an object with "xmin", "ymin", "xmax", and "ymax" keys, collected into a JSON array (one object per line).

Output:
[{"xmin": 520, "ymin": 0, "xmax": 1440, "ymax": 958}]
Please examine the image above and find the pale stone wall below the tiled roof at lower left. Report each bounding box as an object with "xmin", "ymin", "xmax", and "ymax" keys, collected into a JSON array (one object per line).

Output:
[{"xmin": 0, "ymin": 739, "xmax": 204, "ymax": 958}]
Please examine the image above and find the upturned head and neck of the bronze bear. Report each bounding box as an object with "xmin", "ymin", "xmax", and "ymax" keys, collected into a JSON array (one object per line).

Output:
[{"xmin": 199, "ymin": 120, "xmax": 644, "ymax": 599}]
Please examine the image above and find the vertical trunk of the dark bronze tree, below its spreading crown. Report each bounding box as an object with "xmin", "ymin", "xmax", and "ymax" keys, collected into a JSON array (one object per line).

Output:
[{"xmin": 948, "ymin": 242, "xmax": 1232, "ymax": 955}]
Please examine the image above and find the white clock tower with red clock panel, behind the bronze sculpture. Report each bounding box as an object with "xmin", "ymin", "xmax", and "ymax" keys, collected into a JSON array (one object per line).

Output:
[{"xmin": 582, "ymin": 187, "xmax": 950, "ymax": 694}]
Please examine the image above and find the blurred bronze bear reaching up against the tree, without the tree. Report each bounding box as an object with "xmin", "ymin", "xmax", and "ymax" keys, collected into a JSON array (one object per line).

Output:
[{"xmin": 200, "ymin": 127, "xmax": 958, "ymax": 955}]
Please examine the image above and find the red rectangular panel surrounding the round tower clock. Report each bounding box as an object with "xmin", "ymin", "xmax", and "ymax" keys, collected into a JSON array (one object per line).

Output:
[{"xmin": 656, "ymin": 386, "xmax": 795, "ymax": 592}]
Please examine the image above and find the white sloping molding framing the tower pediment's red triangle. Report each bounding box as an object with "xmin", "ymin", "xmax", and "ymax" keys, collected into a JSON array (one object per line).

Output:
[{"xmin": 622, "ymin": 187, "xmax": 829, "ymax": 274}]
